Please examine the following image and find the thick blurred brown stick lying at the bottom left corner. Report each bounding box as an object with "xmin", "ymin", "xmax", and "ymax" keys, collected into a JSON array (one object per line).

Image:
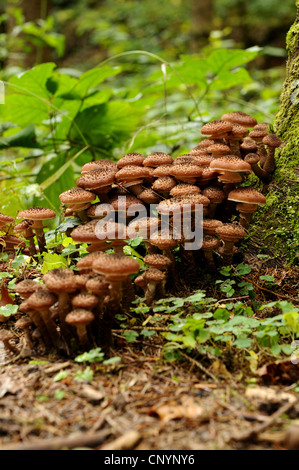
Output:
[{"xmin": 0, "ymin": 429, "xmax": 111, "ymax": 451}]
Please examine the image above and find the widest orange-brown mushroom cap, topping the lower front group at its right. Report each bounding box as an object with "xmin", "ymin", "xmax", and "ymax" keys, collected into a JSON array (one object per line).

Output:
[{"xmin": 92, "ymin": 253, "xmax": 140, "ymax": 279}]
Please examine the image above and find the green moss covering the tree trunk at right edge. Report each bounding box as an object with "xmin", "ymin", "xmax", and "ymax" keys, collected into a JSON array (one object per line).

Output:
[{"xmin": 248, "ymin": 7, "xmax": 299, "ymax": 264}]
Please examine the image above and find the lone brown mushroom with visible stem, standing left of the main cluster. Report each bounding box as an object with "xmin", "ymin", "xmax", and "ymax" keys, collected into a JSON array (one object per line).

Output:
[{"xmin": 17, "ymin": 207, "xmax": 56, "ymax": 253}]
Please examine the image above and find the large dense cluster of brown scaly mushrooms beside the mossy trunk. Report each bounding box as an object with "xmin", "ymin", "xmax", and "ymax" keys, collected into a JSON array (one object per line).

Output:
[{"xmin": 0, "ymin": 112, "xmax": 281, "ymax": 355}]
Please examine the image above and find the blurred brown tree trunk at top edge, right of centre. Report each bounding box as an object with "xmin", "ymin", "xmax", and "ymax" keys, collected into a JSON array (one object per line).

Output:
[{"xmin": 190, "ymin": 0, "xmax": 214, "ymax": 52}]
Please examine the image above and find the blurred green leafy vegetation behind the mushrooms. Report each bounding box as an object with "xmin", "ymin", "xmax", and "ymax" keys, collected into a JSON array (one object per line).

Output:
[{"xmin": 0, "ymin": 0, "xmax": 296, "ymax": 239}]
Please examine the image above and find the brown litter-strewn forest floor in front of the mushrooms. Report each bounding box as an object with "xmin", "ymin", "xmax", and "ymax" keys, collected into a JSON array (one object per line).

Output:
[{"xmin": 0, "ymin": 250, "xmax": 299, "ymax": 451}]
